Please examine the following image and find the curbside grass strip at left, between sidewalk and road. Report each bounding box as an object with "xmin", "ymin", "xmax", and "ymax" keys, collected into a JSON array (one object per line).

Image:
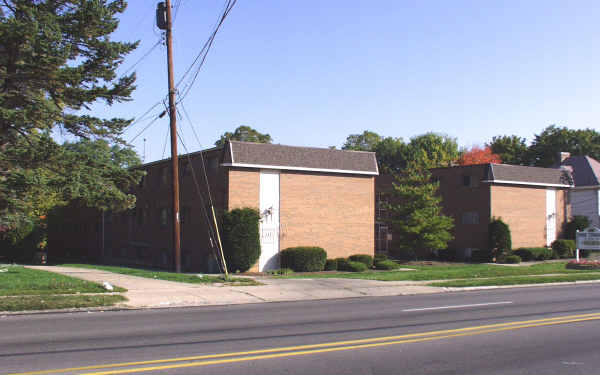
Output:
[{"xmin": 0, "ymin": 295, "xmax": 127, "ymax": 311}]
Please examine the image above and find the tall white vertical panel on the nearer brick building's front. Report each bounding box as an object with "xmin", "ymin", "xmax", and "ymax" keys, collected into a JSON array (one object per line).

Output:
[{"xmin": 258, "ymin": 171, "xmax": 279, "ymax": 271}]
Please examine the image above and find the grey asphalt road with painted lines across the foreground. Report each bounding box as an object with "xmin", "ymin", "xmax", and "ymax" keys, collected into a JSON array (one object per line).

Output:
[{"xmin": 0, "ymin": 284, "xmax": 600, "ymax": 375}]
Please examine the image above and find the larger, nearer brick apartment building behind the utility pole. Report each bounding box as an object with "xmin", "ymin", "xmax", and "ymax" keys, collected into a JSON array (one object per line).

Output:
[{"xmin": 49, "ymin": 141, "xmax": 378, "ymax": 272}]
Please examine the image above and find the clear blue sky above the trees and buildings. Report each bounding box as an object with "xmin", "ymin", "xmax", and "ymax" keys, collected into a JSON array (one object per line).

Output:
[{"xmin": 81, "ymin": 0, "xmax": 600, "ymax": 162}]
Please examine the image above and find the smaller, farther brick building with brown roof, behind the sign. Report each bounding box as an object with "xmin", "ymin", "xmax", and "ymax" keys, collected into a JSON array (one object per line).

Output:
[{"xmin": 431, "ymin": 164, "xmax": 572, "ymax": 256}]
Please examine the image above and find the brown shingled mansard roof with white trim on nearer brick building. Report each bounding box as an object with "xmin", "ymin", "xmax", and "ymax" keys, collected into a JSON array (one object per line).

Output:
[{"xmin": 222, "ymin": 141, "xmax": 379, "ymax": 176}]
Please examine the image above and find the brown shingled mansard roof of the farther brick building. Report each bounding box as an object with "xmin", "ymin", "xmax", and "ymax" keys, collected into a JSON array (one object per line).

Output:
[{"xmin": 485, "ymin": 164, "xmax": 572, "ymax": 187}]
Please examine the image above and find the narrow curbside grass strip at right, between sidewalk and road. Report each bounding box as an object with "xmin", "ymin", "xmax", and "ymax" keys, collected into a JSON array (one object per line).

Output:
[{"xmin": 427, "ymin": 272, "xmax": 600, "ymax": 288}]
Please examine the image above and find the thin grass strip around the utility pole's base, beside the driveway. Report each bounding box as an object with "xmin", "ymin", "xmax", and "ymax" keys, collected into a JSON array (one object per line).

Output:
[{"xmin": 58, "ymin": 264, "xmax": 261, "ymax": 285}]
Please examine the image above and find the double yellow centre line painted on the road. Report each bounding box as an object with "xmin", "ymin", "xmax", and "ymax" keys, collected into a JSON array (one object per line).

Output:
[{"xmin": 10, "ymin": 313, "xmax": 600, "ymax": 375}]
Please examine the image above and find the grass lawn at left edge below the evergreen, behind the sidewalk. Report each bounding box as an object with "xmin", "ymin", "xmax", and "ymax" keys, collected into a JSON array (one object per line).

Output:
[{"xmin": 0, "ymin": 266, "xmax": 126, "ymax": 296}]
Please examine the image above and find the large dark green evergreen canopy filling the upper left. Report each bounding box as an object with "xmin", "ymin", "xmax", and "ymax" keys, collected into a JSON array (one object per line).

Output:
[{"xmin": 0, "ymin": 0, "xmax": 141, "ymax": 234}]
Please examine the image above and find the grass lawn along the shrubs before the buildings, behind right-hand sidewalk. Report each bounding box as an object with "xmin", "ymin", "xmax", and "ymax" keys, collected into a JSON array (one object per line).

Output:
[{"xmin": 277, "ymin": 262, "xmax": 600, "ymax": 285}]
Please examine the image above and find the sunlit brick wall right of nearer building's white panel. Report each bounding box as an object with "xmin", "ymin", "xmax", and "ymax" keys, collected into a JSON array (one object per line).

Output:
[{"xmin": 280, "ymin": 171, "xmax": 375, "ymax": 258}]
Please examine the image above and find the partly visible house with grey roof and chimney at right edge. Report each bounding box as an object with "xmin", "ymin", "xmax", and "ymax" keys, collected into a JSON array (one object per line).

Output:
[{"xmin": 560, "ymin": 152, "xmax": 600, "ymax": 227}]
